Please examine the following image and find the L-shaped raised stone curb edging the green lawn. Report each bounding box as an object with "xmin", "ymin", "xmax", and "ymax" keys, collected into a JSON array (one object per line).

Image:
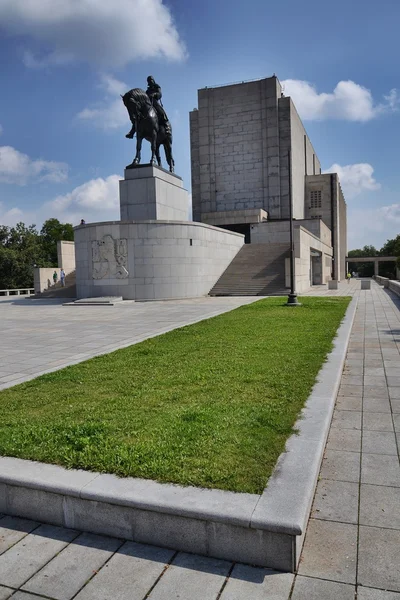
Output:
[{"xmin": 0, "ymin": 298, "xmax": 357, "ymax": 571}]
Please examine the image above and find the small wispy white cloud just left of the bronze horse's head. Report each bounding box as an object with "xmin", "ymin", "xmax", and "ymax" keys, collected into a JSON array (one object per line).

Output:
[{"xmin": 77, "ymin": 75, "xmax": 130, "ymax": 129}]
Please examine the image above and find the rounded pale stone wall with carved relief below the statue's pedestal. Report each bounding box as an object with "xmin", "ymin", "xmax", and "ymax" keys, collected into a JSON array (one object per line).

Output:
[{"xmin": 75, "ymin": 220, "xmax": 244, "ymax": 300}]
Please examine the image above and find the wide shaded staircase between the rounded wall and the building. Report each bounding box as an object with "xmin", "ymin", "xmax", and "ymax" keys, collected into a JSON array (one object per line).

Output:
[{"xmin": 209, "ymin": 244, "xmax": 289, "ymax": 296}]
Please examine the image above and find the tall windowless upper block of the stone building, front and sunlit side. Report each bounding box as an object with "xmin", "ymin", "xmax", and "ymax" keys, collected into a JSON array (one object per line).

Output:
[{"xmin": 190, "ymin": 76, "xmax": 320, "ymax": 220}]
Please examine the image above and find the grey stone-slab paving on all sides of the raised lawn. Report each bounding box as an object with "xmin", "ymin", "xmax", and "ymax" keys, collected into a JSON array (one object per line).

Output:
[{"xmin": 0, "ymin": 280, "xmax": 400, "ymax": 600}]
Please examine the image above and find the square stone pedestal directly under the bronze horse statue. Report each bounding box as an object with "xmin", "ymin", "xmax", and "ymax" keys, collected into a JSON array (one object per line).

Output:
[{"xmin": 119, "ymin": 165, "xmax": 189, "ymax": 221}]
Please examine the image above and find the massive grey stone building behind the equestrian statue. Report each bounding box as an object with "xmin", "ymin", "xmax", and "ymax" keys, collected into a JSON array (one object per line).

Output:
[{"xmin": 190, "ymin": 76, "xmax": 347, "ymax": 289}]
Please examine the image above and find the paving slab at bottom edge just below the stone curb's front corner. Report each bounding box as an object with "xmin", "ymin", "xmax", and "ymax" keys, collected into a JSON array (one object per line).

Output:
[{"xmin": 290, "ymin": 575, "xmax": 356, "ymax": 600}]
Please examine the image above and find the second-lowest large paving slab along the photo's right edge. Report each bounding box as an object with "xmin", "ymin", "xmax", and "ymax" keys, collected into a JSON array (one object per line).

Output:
[{"xmin": 360, "ymin": 484, "xmax": 400, "ymax": 529}]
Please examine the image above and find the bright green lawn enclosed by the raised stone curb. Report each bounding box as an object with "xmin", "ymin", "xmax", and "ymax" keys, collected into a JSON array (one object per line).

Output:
[{"xmin": 0, "ymin": 297, "xmax": 350, "ymax": 493}]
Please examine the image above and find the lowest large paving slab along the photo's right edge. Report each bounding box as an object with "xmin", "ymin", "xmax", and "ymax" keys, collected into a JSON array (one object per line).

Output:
[{"xmin": 358, "ymin": 526, "xmax": 400, "ymax": 592}]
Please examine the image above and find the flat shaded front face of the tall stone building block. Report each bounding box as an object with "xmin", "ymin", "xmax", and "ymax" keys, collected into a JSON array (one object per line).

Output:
[{"xmin": 190, "ymin": 77, "xmax": 281, "ymax": 219}]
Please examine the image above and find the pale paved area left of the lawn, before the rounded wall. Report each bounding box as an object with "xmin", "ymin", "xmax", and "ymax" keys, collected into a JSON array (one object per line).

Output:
[{"xmin": 0, "ymin": 296, "xmax": 260, "ymax": 390}]
